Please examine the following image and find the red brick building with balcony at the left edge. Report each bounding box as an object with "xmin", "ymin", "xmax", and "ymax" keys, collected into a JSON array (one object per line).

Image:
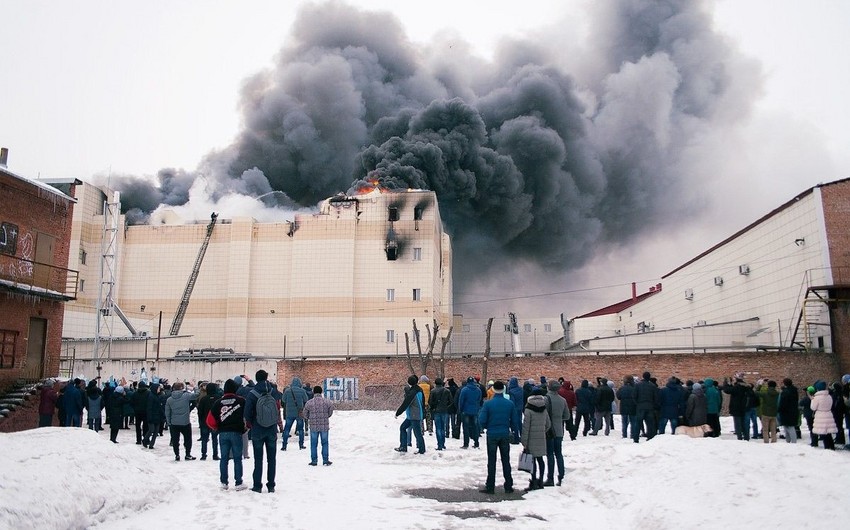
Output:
[{"xmin": 0, "ymin": 149, "xmax": 77, "ymax": 392}]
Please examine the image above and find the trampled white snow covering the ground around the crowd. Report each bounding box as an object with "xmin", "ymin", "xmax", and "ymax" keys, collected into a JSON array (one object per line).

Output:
[{"xmin": 0, "ymin": 411, "xmax": 850, "ymax": 530}]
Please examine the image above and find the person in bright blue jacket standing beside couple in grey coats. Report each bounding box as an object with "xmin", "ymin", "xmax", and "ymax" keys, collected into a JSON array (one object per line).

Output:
[{"xmin": 478, "ymin": 381, "xmax": 519, "ymax": 494}]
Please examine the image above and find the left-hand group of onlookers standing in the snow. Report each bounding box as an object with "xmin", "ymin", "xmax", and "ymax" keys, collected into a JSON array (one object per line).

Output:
[{"xmin": 39, "ymin": 370, "xmax": 334, "ymax": 493}]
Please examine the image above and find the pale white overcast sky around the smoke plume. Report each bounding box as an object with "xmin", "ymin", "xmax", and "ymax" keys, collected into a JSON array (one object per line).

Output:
[{"xmin": 0, "ymin": 0, "xmax": 850, "ymax": 314}]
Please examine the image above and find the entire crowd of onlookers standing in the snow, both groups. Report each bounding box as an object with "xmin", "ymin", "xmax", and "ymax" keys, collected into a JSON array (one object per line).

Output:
[{"xmin": 34, "ymin": 370, "xmax": 850, "ymax": 494}]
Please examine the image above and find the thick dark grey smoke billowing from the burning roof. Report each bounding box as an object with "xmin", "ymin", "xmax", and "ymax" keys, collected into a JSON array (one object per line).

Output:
[{"xmin": 111, "ymin": 0, "xmax": 758, "ymax": 308}]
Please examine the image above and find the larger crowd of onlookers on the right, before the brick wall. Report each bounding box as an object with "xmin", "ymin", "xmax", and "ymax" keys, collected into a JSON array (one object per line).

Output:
[{"xmin": 395, "ymin": 372, "xmax": 850, "ymax": 494}]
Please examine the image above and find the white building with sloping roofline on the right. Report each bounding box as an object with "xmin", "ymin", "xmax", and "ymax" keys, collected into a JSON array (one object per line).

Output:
[{"xmin": 565, "ymin": 179, "xmax": 850, "ymax": 369}]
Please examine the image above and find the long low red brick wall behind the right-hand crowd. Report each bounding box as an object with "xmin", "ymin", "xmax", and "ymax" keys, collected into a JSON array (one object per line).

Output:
[{"xmin": 277, "ymin": 352, "xmax": 840, "ymax": 402}]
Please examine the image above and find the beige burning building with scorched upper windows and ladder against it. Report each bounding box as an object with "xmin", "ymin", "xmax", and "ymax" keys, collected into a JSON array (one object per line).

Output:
[{"xmin": 64, "ymin": 186, "xmax": 452, "ymax": 359}]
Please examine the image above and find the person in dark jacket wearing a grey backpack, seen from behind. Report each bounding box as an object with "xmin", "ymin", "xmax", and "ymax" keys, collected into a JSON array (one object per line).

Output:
[{"xmin": 245, "ymin": 370, "xmax": 284, "ymax": 493}]
